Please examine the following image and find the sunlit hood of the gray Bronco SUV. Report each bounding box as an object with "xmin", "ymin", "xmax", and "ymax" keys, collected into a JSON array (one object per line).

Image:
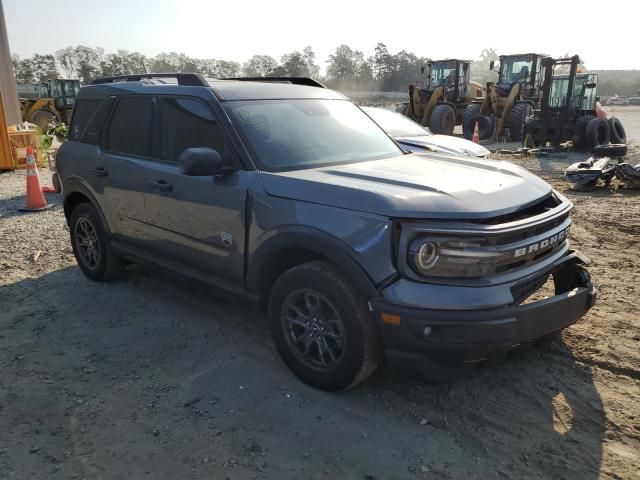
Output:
[{"xmin": 260, "ymin": 153, "xmax": 551, "ymax": 219}]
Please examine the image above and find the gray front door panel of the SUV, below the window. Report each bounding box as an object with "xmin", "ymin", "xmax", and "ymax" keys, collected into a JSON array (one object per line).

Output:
[{"xmin": 136, "ymin": 162, "xmax": 248, "ymax": 282}]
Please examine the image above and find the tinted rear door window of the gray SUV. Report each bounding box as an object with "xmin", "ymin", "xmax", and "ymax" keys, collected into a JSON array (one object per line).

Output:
[{"xmin": 106, "ymin": 97, "xmax": 153, "ymax": 157}]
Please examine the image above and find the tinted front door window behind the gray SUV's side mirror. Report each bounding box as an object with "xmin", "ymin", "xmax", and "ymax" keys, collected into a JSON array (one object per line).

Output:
[{"xmin": 160, "ymin": 97, "xmax": 225, "ymax": 162}]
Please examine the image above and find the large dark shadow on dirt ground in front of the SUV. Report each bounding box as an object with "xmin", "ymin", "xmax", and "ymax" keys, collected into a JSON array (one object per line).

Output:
[{"xmin": 0, "ymin": 268, "xmax": 605, "ymax": 480}]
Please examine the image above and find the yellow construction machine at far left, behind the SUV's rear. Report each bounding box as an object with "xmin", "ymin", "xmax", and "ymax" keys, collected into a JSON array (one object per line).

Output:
[{"xmin": 18, "ymin": 79, "xmax": 80, "ymax": 131}]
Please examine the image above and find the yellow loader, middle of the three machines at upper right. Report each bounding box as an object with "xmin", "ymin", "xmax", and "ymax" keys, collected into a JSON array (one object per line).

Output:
[{"xmin": 462, "ymin": 53, "xmax": 548, "ymax": 142}]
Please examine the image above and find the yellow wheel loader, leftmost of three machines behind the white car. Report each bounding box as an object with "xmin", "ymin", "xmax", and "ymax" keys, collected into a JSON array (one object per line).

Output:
[{"xmin": 403, "ymin": 59, "xmax": 484, "ymax": 135}]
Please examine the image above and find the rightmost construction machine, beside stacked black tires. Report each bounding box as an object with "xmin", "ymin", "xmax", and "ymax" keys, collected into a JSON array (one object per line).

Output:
[{"xmin": 524, "ymin": 55, "xmax": 626, "ymax": 150}]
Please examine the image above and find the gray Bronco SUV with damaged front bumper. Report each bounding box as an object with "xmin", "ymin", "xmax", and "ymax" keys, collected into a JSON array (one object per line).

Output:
[{"xmin": 57, "ymin": 74, "xmax": 595, "ymax": 390}]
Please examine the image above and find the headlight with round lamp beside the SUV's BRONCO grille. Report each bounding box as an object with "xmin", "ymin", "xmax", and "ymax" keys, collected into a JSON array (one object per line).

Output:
[{"xmin": 407, "ymin": 236, "xmax": 504, "ymax": 278}]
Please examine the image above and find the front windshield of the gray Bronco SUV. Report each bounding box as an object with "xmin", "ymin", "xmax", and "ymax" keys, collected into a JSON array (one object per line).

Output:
[{"xmin": 226, "ymin": 100, "xmax": 402, "ymax": 171}]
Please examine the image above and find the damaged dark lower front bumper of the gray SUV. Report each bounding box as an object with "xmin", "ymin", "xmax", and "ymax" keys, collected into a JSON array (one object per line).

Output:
[{"xmin": 370, "ymin": 252, "xmax": 596, "ymax": 371}]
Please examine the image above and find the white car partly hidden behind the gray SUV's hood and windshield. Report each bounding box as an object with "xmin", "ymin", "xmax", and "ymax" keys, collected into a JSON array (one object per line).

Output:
[{"xmin": 362, "ymin": 107, "xmax": 491, "ymax": 158}]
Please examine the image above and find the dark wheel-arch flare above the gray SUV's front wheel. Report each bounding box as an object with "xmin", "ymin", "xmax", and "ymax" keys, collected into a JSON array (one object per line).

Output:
[{"xmin": 246, "ymin": 225, "xmax": 378, "ymax": 298}]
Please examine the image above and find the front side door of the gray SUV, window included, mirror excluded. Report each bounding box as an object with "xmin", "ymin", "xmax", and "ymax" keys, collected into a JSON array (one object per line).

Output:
[{"xmin": 145, "ymin": 96, "xmax": 247, "ymax": 285}]
